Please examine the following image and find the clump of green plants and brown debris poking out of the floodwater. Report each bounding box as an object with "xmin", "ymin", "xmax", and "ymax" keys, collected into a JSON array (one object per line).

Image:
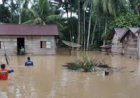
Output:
[{"xmin": 63, "ymin": 57, "xmax": 122, "ymax": 75}]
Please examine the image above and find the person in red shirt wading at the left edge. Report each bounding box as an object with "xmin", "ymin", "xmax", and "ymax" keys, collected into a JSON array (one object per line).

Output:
[{"xmin": 0, "ymin": 64, "xmax": 13, "ymax": 80}]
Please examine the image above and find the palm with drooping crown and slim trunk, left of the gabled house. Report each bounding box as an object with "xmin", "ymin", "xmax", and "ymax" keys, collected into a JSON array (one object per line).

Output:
[{"xmin": 100, "ymin": 0, "xmax": 127, "ymax": 44}]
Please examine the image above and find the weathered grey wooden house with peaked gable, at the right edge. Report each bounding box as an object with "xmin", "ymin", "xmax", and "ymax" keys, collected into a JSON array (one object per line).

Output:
[{"xmin": 111, "ymin": 28, "xmax": 139, "ymax": 56}]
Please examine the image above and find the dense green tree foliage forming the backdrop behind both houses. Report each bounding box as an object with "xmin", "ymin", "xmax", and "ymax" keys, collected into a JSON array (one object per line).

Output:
[{"xmin": 0, "ymin": 0, "xmax": 140, "ymax": 49}]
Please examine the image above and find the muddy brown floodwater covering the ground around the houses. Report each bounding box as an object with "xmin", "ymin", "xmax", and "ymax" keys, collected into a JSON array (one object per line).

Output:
[{"xmin": 0, "ymin": 52, "xmax": 140, "ymax": 98}]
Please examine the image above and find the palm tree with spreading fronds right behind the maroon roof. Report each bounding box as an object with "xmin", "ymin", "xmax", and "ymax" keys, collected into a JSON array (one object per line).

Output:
[{"xmin": 23, "ymin": 0, "xmax": 62, "ymax": 28}]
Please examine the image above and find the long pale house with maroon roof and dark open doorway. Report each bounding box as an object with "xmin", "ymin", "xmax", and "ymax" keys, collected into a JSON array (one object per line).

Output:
[{"xmin": 0, "ymin": 24, "xmax": 58, "ymax": 55}]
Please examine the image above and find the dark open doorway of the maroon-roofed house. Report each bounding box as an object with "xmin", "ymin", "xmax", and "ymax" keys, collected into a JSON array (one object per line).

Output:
[{"xmin": 17, "ymin": 38, "xmax": 25, "ymax": 55}]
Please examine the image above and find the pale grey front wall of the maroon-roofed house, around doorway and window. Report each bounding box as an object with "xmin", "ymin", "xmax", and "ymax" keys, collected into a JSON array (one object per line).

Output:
[{"xmin": 0, "ymin": 36, "xmax": 56, "ymax": 55}]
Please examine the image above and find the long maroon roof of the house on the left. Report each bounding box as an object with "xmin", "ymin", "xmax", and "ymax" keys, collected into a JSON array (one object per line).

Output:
[{"xmin": 0, "ymin": 24, "xmax": 58, "ymax": 36}]
